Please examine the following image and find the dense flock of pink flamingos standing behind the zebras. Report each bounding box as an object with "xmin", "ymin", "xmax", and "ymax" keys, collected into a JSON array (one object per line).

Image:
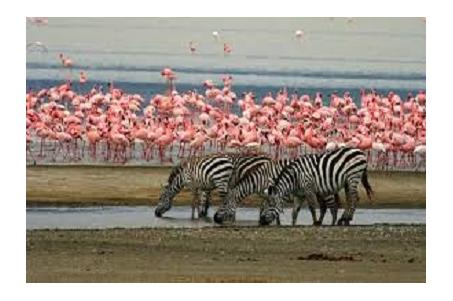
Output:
[{"xmin": 26, "ymin": 59, "xmax": 426, "ymax": 169}]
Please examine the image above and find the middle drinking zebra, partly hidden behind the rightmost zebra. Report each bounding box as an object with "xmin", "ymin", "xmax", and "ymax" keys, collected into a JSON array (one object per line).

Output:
[{"xmin": 214, "ymin": 156, "xmax": 339, "ymax": 224}]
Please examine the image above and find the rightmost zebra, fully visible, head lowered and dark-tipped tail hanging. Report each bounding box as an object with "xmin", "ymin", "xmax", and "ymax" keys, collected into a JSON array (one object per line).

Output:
[{"xmin": 260, "ymin": 148, "xmax": 373, "ymax": 225}]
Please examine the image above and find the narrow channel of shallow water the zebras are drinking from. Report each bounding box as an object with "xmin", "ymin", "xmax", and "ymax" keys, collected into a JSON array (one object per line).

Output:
[{"xmin": 27, "ymin": 206, "xmax": 426, "ymax": 230}]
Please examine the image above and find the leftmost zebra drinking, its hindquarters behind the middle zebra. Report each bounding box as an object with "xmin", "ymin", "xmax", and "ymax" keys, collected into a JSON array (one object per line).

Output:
[{"xmin": 154, "ymin": 153, "xmax": 270, "ymax": 218}]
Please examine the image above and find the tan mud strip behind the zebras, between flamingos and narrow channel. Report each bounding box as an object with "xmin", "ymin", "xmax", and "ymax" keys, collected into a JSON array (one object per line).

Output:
[{"xmin": 26, "ymin": 165, "xmax": 426, "ymax": 208}]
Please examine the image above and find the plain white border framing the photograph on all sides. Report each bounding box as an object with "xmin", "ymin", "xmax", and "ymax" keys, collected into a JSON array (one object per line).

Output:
[{"xmin": 1, "ymin": 0, "xmax": 453, "ymax": 301}]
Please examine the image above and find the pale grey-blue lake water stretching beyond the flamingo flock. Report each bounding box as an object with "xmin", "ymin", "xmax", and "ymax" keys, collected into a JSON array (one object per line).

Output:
[{"xmin": 26, "ymin": 18, "xmax": 426, "ymax": 101}]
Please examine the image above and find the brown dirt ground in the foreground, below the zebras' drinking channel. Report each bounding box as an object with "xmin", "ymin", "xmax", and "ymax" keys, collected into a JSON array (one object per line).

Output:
[{"xmin": 26, "ymin": 225, "xmax": 426, "ymax": 282}]
